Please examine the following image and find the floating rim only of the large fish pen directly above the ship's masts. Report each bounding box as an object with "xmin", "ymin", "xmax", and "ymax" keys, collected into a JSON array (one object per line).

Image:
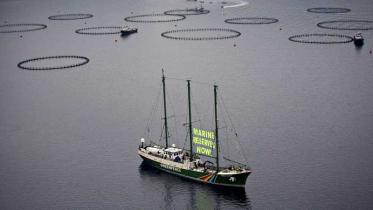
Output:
[{"xmin": 161, "ymin": 28, "xmax": 241, "ymax": 40}]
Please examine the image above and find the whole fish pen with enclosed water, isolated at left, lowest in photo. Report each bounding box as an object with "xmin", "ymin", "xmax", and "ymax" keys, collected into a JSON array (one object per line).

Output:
[{"xmin": 17, "ymin": 55, "xmax": 89, "ymax": 70}]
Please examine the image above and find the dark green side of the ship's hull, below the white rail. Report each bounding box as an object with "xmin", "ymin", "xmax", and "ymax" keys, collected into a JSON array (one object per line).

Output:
[{"xmin": 139, "ymin": 151, "xmax": 251, "ymax": 187}]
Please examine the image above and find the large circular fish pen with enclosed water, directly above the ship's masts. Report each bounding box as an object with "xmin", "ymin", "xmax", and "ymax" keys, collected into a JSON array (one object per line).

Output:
[{"xmin": 161, "ymin": 28, "xmax": 241, "ymax": 41}]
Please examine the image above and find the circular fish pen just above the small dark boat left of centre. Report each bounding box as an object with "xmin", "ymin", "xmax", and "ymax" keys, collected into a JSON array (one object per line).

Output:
[{"xmin": 124, "ymin": 14, "xmax": 186, "ymax": 23}]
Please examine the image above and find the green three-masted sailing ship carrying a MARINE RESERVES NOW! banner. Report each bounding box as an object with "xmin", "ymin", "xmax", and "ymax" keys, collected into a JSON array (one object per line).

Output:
[{"xmin": 138, "ymin": 71, "xmax": 251, "ymax": 188}]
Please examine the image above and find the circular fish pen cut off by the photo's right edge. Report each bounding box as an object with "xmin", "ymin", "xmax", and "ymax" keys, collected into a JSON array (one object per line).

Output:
[{"xmin": 317, "ymin": 20, "xmax": 373, "ymax": 31}]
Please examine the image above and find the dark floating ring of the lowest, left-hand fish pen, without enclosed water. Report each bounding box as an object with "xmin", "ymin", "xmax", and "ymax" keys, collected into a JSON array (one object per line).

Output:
[{"xmin": 17, "ymin": 55, "xmax": 89, "ymax": 70}]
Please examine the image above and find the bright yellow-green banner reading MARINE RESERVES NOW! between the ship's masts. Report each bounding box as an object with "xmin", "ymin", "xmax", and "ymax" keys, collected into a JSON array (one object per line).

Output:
[{"xmin": 193, "ymin": 128, "xmax": 216, "ymax": 157}]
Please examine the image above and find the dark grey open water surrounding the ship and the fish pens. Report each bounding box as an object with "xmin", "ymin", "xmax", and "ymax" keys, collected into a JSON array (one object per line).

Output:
[{"xmin": 0, "ymin": 0, "xmax": 373, "ymax": 209}]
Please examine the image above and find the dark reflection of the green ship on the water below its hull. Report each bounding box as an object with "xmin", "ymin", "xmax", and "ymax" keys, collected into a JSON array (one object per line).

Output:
[{"xmin": 139, "ymin": 163, "xmax": 251, "ymax": 209}]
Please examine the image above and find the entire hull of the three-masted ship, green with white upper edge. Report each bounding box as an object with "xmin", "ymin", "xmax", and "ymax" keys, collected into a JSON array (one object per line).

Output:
[{"xmin": 139, "ymin": 150, "xmax": 251, "ymax": 188}]
